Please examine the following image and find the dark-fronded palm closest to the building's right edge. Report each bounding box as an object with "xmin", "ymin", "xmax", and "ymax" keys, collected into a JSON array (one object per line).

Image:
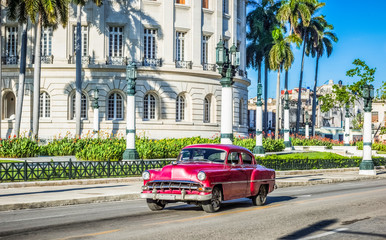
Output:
[{"xmin": 247, "ymin": 0, "xmax": 280, "ymax": 130}]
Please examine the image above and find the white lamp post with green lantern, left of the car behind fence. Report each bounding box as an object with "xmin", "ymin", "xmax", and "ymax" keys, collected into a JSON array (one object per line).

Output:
[{"xmin": 123, "ymin": 62, "xmax": 139, "ymax": 160}]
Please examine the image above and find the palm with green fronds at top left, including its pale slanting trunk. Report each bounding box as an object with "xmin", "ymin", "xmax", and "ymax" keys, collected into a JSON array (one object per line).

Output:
[{"xmin": 27, "ymin": 0, "xmax": 69, "ymax": 140}]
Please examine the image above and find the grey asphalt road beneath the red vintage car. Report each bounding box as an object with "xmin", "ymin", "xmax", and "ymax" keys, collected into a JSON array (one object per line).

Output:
[{"xmin": 0, "ymin": 180, "xmax": 386, "ymax": 240}]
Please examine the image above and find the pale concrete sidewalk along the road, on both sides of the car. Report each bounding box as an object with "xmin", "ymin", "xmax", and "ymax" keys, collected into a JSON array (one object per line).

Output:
[{"xmin": 0, "ymin": 168, "xmax": 386, "ymax": 211}]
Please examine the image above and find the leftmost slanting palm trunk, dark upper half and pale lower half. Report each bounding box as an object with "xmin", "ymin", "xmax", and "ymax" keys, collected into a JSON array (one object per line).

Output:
[{"xmin": 14, "ymin": 22, "xmax": 28, "ymax": 137}]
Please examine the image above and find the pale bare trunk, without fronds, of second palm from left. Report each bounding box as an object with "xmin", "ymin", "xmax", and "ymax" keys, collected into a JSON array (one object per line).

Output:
[{"xmin": 32, "ymin": 15, "xmax": 42, "ymax": 141}]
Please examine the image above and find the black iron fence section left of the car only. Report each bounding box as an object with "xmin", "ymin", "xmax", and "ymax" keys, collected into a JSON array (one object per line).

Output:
[{"xmin": 0, "ymin": 159, "xmax": 172, "ymax": 182}]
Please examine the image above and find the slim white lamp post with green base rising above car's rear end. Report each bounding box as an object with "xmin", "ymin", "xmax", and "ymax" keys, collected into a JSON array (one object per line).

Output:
[{"xmin": 253, "ymin": 83, "xmax": 265, "ymax": 155}]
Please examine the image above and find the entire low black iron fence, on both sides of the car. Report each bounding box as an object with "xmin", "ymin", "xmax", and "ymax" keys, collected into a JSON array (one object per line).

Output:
[{"xmin": 0, "ymin": 158, "xmax": 386, "ymax": 182}]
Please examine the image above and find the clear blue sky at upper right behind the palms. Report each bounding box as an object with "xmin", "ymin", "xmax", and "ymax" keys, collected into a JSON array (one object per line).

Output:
[{"xmin": 248, "ymin": 0, "xmax": 386, "ymax": 98}]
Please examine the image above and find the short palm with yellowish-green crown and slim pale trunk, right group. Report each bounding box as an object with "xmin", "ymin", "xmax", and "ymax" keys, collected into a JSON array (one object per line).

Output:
[{"xmin": 269, "ymin": 28, "xmax": 294, "ymax": 139}]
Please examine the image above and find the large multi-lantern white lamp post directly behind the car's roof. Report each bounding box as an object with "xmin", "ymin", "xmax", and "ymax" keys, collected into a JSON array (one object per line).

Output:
[{"xmin": 216, "ymin": 38, "xmax": 240, "ymax": 144}]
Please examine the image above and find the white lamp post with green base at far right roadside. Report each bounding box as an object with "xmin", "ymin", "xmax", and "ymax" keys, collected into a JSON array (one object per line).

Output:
[{"xmin": 359, "ymin": 84, "xmax": 377, "ymax": 175}]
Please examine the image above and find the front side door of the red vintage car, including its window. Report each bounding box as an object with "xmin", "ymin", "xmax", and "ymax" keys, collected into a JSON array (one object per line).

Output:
[{"xmin": 227, "ymin": 151, "xmax": 248, "ymax": 199}]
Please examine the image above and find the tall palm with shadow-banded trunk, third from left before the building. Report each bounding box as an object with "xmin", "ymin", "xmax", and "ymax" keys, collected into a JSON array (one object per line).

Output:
[{"xmin": 72, "ymin": 0, "xmax": 103, "ymax": 137}]
